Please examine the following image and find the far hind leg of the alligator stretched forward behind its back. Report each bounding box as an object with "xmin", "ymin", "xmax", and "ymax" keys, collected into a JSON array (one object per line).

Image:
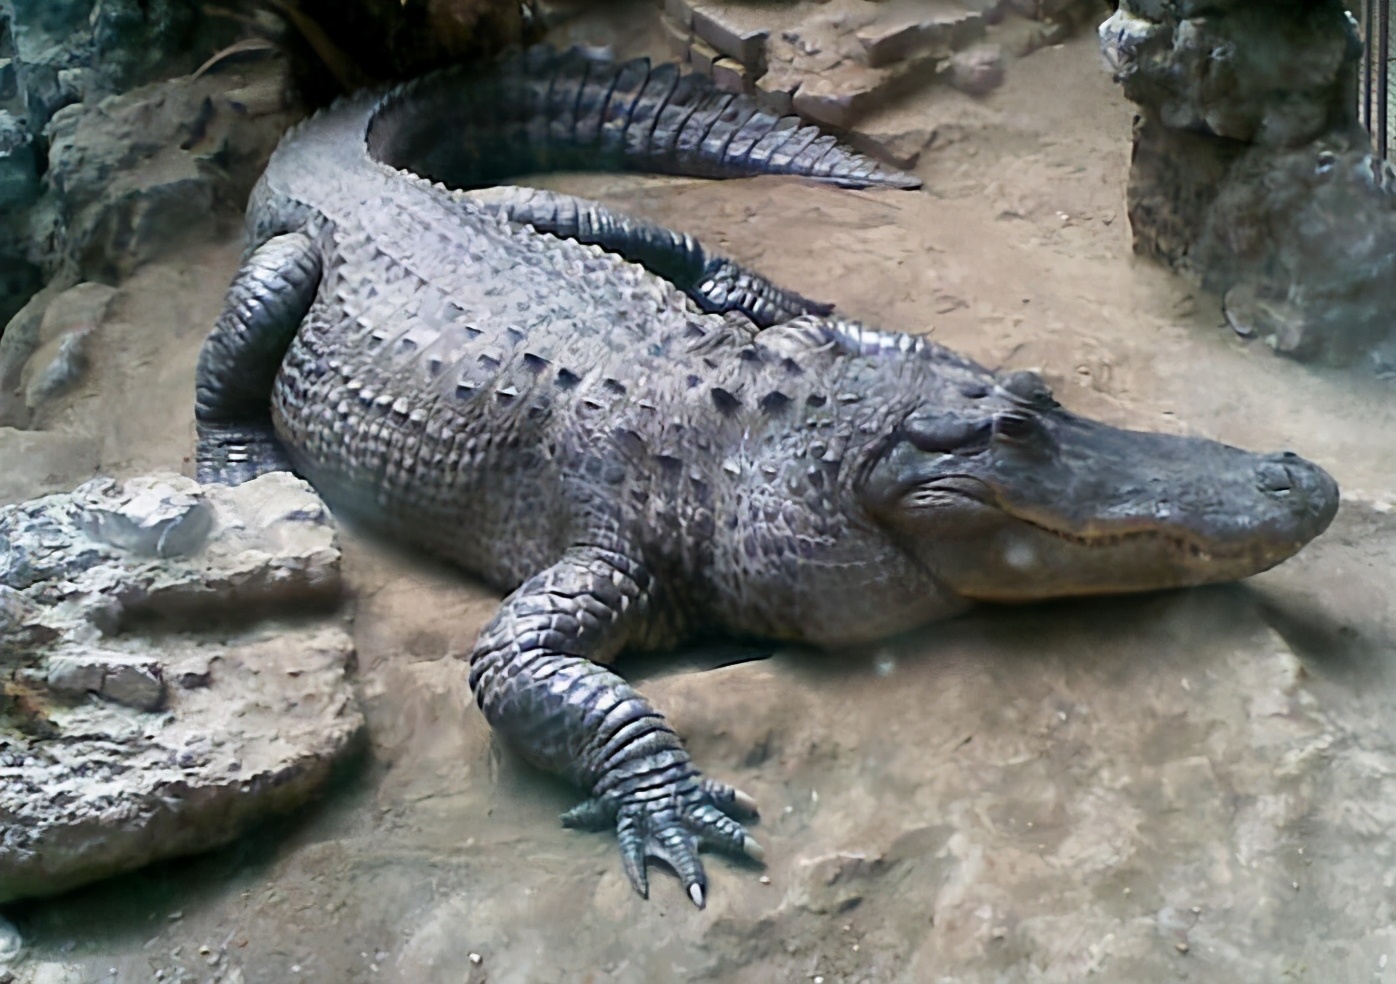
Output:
[{"xmin": 466, "ymin": 186, "xmax": 833, "ymax": 328}]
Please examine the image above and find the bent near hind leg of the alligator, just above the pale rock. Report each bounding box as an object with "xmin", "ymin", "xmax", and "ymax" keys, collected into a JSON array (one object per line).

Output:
[{"xmin": 194, "ymin": 232, "xmax": 320, "ymax": 486}]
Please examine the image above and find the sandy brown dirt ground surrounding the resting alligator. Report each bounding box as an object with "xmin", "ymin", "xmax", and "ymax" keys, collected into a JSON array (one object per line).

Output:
[{"xmin": 6, "ymin": 13, "xmax": 1396, "ymax": 984}]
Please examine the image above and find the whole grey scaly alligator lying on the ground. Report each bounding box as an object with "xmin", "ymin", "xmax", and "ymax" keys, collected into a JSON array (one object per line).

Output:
[{"xmin": 195, "ymin": 49, "xmax": 1339, "ymax": 907}]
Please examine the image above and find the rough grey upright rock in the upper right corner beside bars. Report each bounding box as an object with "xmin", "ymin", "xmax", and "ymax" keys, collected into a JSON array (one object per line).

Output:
[{"xmin": 1100, "ymin": 0, "xmax": 1396, "ymax": 373}]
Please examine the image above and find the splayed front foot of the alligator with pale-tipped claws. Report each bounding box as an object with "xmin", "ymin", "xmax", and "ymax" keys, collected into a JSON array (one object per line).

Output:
[{"xmin": 563, "ymin": 777, "xmax": 766, "ymax": 909}]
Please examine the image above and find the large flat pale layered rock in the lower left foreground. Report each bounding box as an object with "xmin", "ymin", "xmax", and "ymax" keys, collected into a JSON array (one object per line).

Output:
[{"xmin": 0, "ymin": 472, "xmax": 363, "ymax": 902}]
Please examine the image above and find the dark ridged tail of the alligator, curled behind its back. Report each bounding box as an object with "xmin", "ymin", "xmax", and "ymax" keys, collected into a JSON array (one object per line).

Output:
[{"xmin": 369, "ymin": 46, "xmax": 921, "ymax": 188}]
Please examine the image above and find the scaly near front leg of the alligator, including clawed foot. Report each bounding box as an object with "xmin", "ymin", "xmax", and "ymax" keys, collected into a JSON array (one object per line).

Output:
[{"xmin": 470, "ymin": 547, "xmax": 764, "ymax": 907}]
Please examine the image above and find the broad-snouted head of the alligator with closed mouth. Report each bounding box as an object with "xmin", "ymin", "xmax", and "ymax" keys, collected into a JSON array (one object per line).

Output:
[{"xmin": 861, "ymin": 373, "xmax": 1339, "ymax": 602}]
